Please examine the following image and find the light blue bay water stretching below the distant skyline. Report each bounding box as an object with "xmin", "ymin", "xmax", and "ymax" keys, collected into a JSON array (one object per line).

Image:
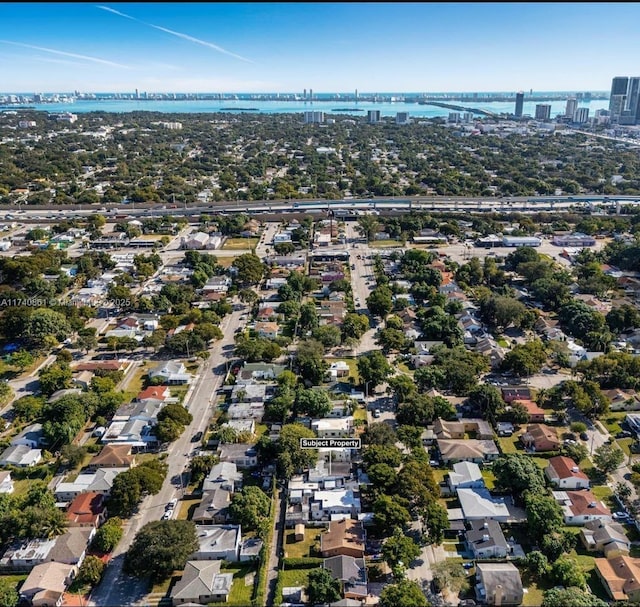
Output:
[{"xmin": 3, "ymin": 99, "xmax": 609, "ymax": 118}]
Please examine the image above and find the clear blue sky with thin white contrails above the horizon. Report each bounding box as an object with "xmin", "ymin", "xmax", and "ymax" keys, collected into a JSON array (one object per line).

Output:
[{"xmin": 0, "ymin": 2, "xmax": 640, "ymax": 92}]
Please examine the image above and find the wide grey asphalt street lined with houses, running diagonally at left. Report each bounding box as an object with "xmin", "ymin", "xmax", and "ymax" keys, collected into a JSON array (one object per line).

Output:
[{"xmin": 87, "ymin": 310, "xmax": 244, "ymax": 607}]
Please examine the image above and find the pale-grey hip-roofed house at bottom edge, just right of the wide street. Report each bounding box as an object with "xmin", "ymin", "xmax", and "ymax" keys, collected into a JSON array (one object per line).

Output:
[{"xmin": 171, "ymin": 560, "xmax": 233, "ymax": 607}]
